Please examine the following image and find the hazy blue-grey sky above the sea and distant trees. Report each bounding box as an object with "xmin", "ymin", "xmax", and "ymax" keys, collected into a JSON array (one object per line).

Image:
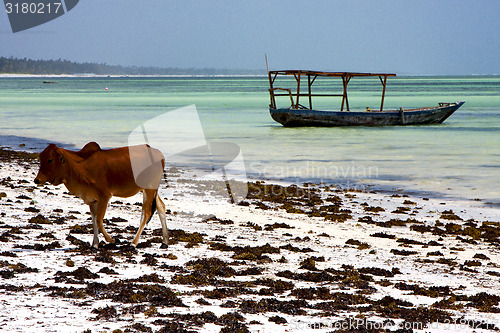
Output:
[{"xmin": 0, "ymin": 0, "xmax": 500, "ymax": 75}]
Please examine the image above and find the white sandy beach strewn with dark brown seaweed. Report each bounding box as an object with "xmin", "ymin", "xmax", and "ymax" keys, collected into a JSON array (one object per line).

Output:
[{"xmin": 0, "ymin": 150, "xmax": 500, "ymax": 332}]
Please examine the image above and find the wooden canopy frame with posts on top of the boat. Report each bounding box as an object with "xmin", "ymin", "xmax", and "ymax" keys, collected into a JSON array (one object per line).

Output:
[{"xmin": 268, "ymin": 69, "xmax": 396, "ymax": 111}]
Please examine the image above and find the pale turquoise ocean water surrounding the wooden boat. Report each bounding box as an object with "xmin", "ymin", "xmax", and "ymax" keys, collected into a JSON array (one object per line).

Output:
[{"xmin": 0, "ymin": 76, "xmax": 500, "ymax": 205}]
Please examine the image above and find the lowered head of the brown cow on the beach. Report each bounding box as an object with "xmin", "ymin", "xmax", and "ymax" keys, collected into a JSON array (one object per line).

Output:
[{"xmin": 35, "ymin": 143, "xmax": 65, "ymax": 185}]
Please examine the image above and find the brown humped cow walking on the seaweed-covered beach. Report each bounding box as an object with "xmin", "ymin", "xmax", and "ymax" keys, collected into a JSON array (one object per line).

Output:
[{"xmin": 35, "ymin": 142, "xmax": 168, "ymax": 249}]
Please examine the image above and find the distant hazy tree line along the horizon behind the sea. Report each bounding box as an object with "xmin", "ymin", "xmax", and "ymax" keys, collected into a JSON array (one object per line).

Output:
[{"xmin": 0, "ymin": 57, "xmax": 265, "ymax": 75}]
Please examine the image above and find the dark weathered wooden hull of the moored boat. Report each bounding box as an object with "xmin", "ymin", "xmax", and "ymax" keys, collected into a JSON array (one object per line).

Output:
[{"xmin": 269, "ymin": 102, "xmax": 464, "ymax": 127}]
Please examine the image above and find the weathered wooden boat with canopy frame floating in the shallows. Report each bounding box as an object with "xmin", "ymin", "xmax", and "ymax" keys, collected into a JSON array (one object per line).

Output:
[{"xmin": 268, "ymin": 70, "xmax": 464, "ymax": 127}]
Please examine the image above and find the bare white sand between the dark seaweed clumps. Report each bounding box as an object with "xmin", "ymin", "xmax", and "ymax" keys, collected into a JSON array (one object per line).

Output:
[{"xmin": 0, "ymin": 154, "xmax": 500, "ymax": 332}]
